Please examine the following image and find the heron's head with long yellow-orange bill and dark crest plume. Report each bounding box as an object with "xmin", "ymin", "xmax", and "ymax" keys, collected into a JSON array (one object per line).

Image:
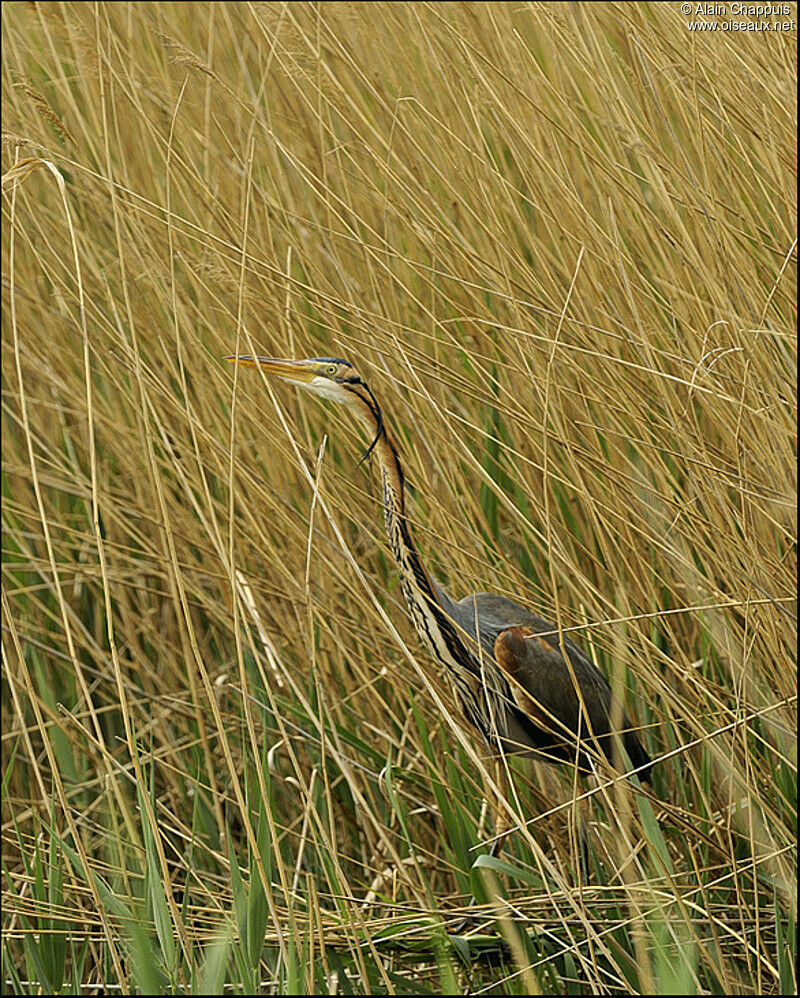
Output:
[{"xmin": 225, "ymin": 354, "xmax": 385, "ymax": 460}]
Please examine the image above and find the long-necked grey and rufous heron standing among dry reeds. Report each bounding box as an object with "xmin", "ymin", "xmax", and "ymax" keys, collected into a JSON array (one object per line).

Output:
[{"xmin": 229, "ymin": 357, "xmax": 651, "ymax": 792}]
